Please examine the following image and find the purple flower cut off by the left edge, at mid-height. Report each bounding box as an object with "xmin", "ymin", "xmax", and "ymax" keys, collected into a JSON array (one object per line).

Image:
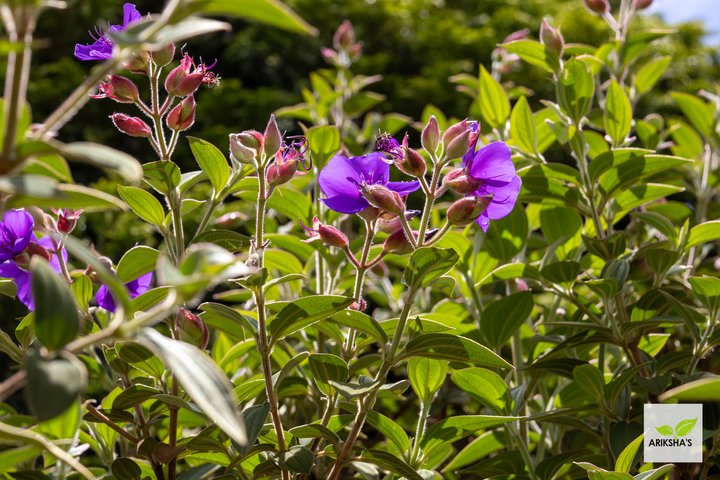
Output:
[{"xmin": 0, "ymin": 210, "xmax": 67, "ymax": 310}]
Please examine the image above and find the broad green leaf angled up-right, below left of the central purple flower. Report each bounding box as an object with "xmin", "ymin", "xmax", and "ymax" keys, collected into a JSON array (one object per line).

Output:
[{"xmin": 268, "ymin": 295, "xmax": 355, "ymax": 342}]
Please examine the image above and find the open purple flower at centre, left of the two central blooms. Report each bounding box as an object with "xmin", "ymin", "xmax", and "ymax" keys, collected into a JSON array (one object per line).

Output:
[{"xmin": 318, "ymin": 152, "xmax": 420, "ymax": 213}]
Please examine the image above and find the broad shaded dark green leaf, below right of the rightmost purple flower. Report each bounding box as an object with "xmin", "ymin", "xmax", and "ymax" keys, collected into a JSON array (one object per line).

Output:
[{"xmin": 481, "ymin": 292, "xmax": 533, "ymax": 349}]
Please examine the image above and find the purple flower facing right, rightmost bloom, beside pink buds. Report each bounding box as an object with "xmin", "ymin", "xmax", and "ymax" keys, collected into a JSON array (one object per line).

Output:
[{"xmin": 463, "ymin": 139, "xmax": 522, "ymax": 232}]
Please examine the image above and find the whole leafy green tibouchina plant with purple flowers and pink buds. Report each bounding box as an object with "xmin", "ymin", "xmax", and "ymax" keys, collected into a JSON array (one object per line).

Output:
[{"xmin": 0, "ymin": 0, "xmax": 720, "ymax": 480}]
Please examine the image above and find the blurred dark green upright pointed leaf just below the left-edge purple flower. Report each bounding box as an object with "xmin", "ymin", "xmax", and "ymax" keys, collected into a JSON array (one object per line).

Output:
[{"xmin": 30, "ymin": 256, "xmax": 80, "ymax": 350}]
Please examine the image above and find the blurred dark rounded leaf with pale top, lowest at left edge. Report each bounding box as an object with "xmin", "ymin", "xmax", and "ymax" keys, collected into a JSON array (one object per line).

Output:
[{"xmin": 25, "ymin": 350, "xmax": 87, "ymax": 421}]
